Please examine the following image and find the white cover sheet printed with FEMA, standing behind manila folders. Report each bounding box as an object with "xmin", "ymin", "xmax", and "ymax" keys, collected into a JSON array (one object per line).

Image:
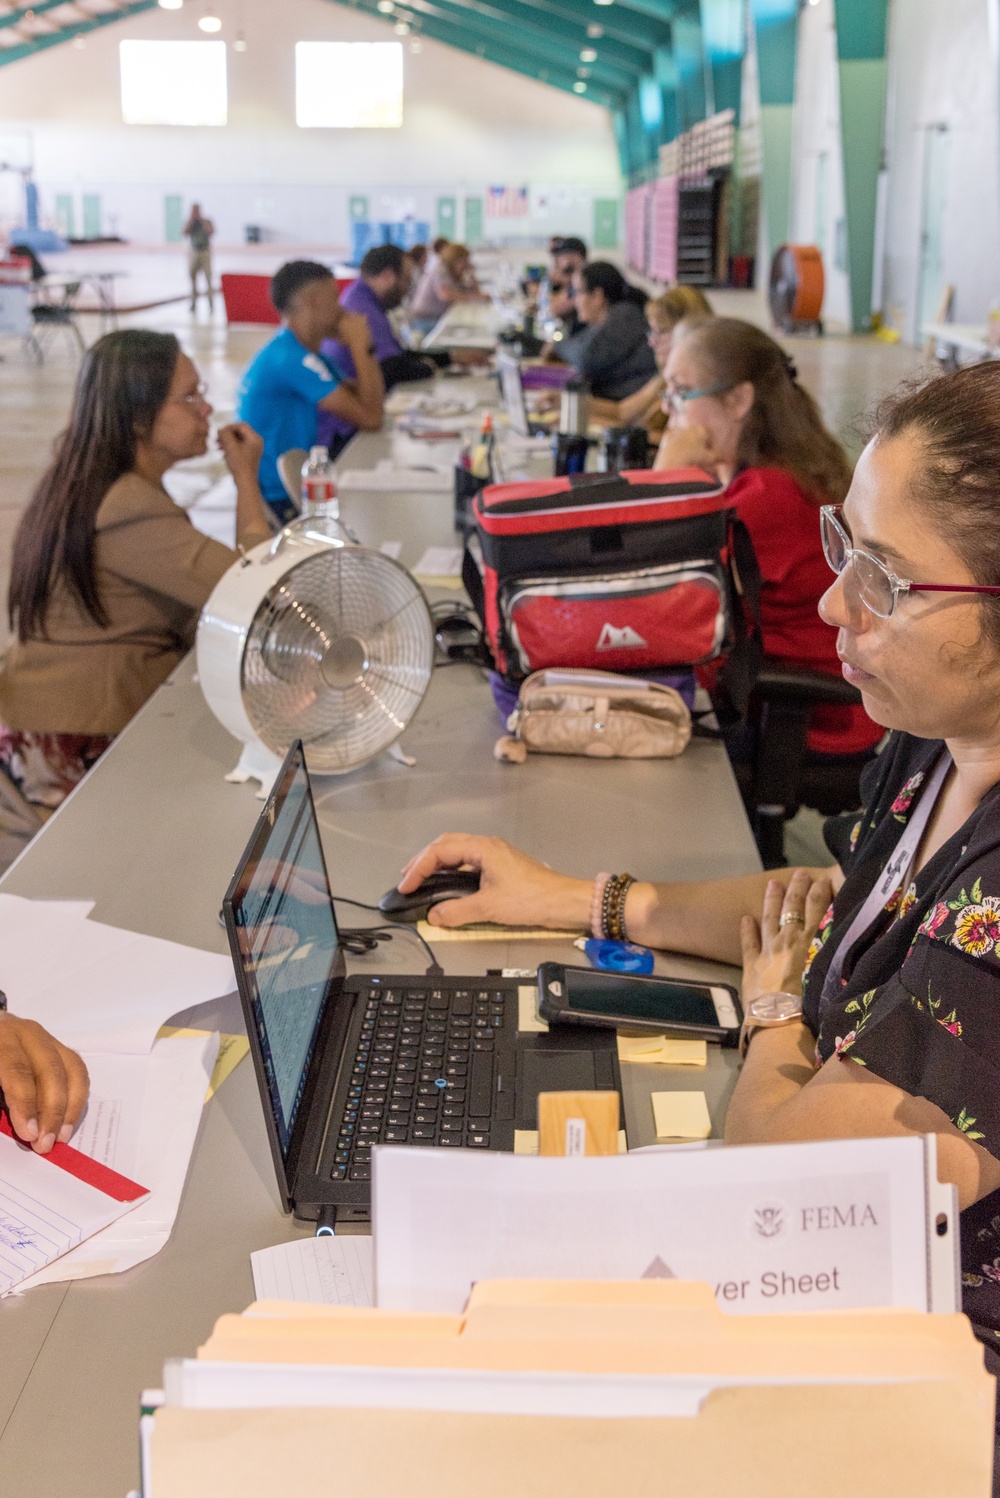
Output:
[{"xmin": 373, "ymin": 1135, "xmax": 958, "ymax": 1314}]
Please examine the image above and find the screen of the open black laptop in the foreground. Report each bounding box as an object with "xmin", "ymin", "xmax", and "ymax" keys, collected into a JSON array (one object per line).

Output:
[{"xmin": 228, "ymin": 745, "xmax": 340, "ymax": 1159}]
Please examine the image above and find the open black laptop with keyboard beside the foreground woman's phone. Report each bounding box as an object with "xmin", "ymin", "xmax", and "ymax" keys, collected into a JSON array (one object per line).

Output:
[{"xmin": 223, "ymin": 743, "xmax": 621, "ymax": 1221}]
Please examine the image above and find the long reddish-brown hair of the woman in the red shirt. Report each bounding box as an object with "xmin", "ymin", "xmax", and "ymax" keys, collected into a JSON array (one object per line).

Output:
[{"xmin": 675, "ymin": 318, "xmax": 852, "ymax": 505}]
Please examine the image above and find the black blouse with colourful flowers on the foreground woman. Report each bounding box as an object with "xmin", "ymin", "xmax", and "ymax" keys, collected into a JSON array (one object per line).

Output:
[{"xmin": 802, "ymin": 734, "xmax": 1000, "ymax": 1362}]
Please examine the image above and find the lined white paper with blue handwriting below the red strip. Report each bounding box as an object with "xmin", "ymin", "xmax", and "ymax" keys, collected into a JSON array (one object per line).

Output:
[{"xmin": 0, "ymin": 1134, "xmax": 147, "ymax": 1294}]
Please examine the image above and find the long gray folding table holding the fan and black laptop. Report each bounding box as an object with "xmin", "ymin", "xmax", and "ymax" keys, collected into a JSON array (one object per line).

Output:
[{"xmin": 0, "ymin": 389, "xmax": 759, "ymax": 1498}]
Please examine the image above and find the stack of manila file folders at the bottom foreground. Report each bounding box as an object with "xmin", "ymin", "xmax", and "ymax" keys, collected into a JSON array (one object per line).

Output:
[{"xmin": 144, "ymin": 1279, "xmax": 994, "ymax": 1498}]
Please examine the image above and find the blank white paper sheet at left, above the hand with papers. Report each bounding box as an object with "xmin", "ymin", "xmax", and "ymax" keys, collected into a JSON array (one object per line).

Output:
[{"xmin": 0, "ymin": 894, "xmax": 235, "ymax": 1053}]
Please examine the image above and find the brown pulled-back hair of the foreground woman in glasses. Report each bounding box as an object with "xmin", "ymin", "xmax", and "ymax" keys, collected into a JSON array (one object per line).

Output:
[{"xmin": 873, "ymin": 360, "xmax": 1000, "ymax": 647}]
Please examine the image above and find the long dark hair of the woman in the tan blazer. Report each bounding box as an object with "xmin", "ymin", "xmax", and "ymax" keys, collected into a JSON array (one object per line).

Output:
[{"xmin": 7, "ymin": 328, "xmax": 181, "ymax": 640}]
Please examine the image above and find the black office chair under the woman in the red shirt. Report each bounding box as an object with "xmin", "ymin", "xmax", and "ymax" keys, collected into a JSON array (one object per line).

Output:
[{"xmin": 735, "ymin": 659, "xmax": 871, "ymax": 869}]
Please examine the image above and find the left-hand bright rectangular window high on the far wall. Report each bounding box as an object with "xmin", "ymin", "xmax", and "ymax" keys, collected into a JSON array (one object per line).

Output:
[{"xmin": 118, "ymin": 42, "xmax": 229, "ymax": 126}]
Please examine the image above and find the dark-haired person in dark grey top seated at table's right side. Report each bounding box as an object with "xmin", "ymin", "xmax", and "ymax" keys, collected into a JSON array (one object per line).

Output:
[{"xmin": 558, "ymin": 261, "xmax": 657, "ymax": 400}]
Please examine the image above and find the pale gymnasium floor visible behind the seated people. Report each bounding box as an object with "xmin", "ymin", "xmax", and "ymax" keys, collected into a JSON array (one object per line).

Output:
[{"xmin": 0, "ymin": 246, "xmax": 927, "ymax": 863}]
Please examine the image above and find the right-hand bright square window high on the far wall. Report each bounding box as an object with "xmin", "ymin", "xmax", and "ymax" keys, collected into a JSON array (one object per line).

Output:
[{"xmin": 295, "ymin": 42, "xmax": 403, "ymax": 130}]
